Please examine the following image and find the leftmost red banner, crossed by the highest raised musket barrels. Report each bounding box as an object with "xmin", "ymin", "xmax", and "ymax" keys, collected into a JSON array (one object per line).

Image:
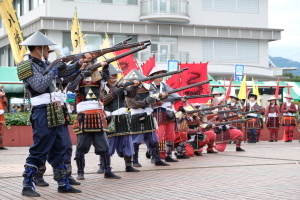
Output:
[{"xmin": 115, "ymin": 49, "xmax": 139, "ymax": 76}]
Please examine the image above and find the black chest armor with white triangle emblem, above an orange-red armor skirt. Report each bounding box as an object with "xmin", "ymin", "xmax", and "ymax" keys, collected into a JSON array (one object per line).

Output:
[{"xmin": 79, "ymin": 81, "xmax": 100, "ymax": 101}]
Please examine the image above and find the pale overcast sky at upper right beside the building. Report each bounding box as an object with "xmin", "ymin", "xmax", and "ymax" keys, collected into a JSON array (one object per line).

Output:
[{"xmin": 268, "ymin": 0, "xmax": 300, "ymax": 62}]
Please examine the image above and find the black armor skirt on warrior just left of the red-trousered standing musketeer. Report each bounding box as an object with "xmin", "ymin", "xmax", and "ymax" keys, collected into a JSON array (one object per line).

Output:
[{"xmin": 130, "ymin": 113, "xmax": 155, "ymax": 134}]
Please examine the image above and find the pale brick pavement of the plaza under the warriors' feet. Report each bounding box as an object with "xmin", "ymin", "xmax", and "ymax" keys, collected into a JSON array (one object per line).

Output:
[{"xmin": 0, "ymin": 141, "xmax": 300, "ymax": 200}]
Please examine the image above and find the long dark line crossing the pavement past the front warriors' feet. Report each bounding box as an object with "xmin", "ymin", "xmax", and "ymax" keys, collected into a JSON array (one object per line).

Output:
[{"xmin": 0, "ymin": 162, "xmax": 295, "ymax": 179}]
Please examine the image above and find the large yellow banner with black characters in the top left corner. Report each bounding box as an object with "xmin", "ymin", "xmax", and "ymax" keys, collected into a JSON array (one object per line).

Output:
[{"xmin": 0, "ymin": 0, "xmax": 26, "ymax": 64}]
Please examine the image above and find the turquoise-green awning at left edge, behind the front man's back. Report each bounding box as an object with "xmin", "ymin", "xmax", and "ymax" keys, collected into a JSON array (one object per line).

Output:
[{"xmin": 0, "ymin": 67, "xmax": 24, "ymax": 97}]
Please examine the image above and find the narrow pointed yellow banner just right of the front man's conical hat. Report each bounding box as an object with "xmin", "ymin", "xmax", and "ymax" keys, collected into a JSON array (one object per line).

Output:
[{"xmin": 71, "ymin": 8, "xmax": 88, "ymax": 54}]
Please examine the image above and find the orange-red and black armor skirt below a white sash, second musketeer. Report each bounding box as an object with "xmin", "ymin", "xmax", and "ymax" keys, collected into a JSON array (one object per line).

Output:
[{"xmin": 73, "ymin": 109, "xmax": 107, "ymax": 134}]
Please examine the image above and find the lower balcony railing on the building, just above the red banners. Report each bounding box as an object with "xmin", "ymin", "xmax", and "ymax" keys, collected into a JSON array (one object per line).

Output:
[{"xmin": 141, "ymin": 51, "xmax": 189, "ymax": 63}]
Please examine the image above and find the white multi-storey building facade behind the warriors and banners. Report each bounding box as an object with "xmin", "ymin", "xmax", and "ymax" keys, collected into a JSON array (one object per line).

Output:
[{"xmin": 0, "ymin": 0, "xmax": 283, "ymax": 80}]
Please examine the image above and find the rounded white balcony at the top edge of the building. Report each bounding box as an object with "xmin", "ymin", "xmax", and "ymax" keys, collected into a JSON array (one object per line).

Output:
[{"xmin": 140, "ymin": 0, "xmax": 190, "ymax": 21}]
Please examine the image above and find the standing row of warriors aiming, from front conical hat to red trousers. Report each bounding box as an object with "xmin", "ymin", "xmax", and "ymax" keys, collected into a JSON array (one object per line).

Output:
[{"xmin": 18, "ymin": 32, "xmax": 193, "ymax": 197}]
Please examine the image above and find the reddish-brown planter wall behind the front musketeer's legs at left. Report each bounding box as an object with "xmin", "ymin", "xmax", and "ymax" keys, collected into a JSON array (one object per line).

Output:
[{"xmin": 3, "ymin": 125, "xmax": 76, "ymax": 147}]
